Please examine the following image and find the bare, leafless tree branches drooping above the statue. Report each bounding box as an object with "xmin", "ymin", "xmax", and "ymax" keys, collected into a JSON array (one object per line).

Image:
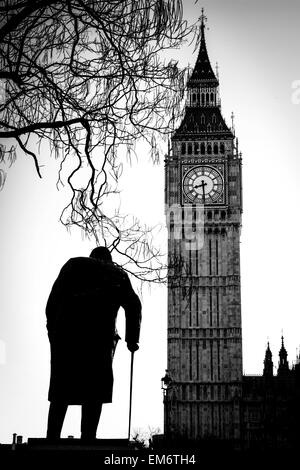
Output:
[{"xmin": 0, "ymin": 0, "xmax": 202, "ymax": 282}]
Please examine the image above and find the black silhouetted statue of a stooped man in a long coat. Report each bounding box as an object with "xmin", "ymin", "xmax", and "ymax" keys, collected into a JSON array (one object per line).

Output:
[{"xmin": 46, "ymin": 247, "xmax": 141, "ymax": 440}]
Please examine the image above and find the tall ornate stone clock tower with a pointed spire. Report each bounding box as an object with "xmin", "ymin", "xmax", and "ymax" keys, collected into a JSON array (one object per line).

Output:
[{"xmin": 164, "ymin": 10, "xmax": 242, "ymax": 441}]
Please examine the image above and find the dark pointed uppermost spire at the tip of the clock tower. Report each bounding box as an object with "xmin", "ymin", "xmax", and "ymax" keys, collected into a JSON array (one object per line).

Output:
[{"xmin": 187, "ymin": 8, "xmax": 219, "ymax": 88}]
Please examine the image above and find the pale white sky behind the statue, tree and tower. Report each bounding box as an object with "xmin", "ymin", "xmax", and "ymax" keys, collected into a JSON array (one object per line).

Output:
[{"xmin": 0, "ymin": 0, "xmax": 300, "ymax": 442}]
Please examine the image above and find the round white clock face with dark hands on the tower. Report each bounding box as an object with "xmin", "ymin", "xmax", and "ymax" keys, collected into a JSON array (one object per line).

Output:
[{"xmin": 183, "ymin": 165, "xmax": 224, "ymax": 204}]
